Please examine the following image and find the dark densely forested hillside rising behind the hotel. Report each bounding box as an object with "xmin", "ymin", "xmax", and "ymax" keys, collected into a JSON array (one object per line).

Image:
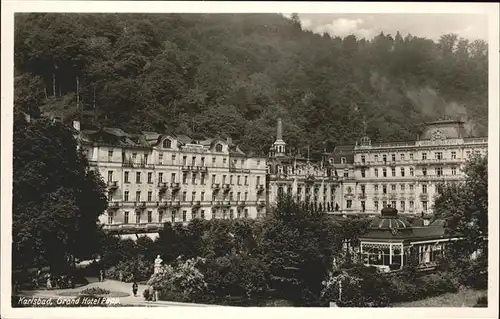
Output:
[{"xmin": 15, "ymin": 14, "xmax": 488, "ymax": 156}]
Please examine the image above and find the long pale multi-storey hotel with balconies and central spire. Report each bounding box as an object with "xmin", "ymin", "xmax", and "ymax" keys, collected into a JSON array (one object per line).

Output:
[{"xmin": 74, "ymin": 120, "xmax": 488, "ymax": 232}]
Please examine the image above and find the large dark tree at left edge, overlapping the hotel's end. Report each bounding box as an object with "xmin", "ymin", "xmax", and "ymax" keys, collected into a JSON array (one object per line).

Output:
[{"xmin": 12, "ymin": 112, "xmax": 107, "ymax": 269}]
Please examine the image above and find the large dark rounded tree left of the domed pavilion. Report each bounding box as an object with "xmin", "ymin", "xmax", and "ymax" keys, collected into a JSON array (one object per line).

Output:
[{"xmin": 260, "ymin": 195, "xmax": 335, "ymax": 305}]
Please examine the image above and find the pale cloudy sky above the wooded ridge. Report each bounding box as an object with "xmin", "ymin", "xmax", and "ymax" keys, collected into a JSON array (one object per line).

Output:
[{"xmin": 287, "ymin": 13, "xmax": 488, "ymax": 41}]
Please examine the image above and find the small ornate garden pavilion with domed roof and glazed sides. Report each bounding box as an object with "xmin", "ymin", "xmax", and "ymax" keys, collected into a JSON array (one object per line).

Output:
[{"xmin": 359, "ymin": 205, "xmax": 456, "ymax": 272}]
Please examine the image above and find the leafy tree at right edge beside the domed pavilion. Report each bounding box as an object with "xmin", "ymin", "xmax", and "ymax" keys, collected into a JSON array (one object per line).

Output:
[{"xmin": 434, "ymin": 154, "xmax": 488, "ymax": 290}]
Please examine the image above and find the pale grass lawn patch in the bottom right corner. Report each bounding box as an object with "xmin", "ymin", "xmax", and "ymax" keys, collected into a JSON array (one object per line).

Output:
[{"xmin": 392, "ymin": 288, "xmax": 488, "ymax": 307}]
